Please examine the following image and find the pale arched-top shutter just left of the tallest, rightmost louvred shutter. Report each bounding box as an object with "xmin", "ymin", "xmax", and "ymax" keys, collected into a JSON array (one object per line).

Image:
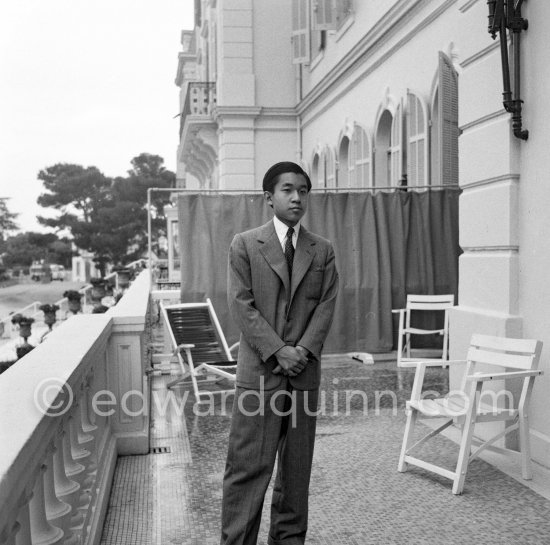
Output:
[{"xmin": 407, "ymin": 91, "xmax": 428, "ymax": 186}]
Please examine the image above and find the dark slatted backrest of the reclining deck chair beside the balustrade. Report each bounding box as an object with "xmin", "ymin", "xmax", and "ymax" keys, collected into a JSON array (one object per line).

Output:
[{"xmin": 162, "ymin": 299, "xmax": 233, "ymax": 365}]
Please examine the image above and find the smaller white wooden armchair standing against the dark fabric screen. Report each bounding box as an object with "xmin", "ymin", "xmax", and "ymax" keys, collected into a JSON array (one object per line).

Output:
[{"xmin": 392, "ymin": 294, "xmax": 454, "ymax": 367}]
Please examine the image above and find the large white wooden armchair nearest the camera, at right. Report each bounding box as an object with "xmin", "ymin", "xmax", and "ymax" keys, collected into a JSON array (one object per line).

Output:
[{"xmin": 398, "ymin": 335, "xmax": 542, "ymax": 494}]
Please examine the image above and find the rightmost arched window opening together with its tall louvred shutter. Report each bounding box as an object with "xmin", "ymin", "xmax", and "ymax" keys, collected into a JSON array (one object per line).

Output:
[{"xmin": 430, "ymin": 51, "xmax": 459, "ymax": 185}]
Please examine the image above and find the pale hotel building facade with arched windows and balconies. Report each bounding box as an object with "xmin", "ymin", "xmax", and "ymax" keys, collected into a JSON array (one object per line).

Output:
[{"xmin": 176, "ymin": 0, "xmax": 550, "ymax": 466}]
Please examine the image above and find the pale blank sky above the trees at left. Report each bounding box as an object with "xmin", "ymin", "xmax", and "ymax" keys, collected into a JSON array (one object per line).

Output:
[{"xmin": 0, "ymin": 0, "xmax": 194, "ymax": 231}]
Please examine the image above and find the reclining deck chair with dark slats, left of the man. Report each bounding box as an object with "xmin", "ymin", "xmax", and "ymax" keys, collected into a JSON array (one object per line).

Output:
[{"xmin": 161, "ymin": 299, "xmax": 238, "ymax": 403}]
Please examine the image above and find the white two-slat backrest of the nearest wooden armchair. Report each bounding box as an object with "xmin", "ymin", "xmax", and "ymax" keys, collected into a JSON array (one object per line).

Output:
[{"xmin": 466, "ymin": 335, "xmax": 542, "ymax": 371}]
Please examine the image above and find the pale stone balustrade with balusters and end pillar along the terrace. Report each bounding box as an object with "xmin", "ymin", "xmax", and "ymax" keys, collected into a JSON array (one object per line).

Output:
[{"xmin": 0, "ymin": 271, "xmax": 149, "ymax": 545}]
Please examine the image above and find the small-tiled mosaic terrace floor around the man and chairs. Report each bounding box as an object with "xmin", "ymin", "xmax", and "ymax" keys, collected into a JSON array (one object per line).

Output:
[{"xmin": 101, "ymin": 356, "xmax": 550, "ymax": 545}]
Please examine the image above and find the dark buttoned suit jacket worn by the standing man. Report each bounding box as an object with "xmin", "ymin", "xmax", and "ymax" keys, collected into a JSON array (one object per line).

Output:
[{"xmin": 228, "ymin": 221, "xmax": 338, "ymax": 390}]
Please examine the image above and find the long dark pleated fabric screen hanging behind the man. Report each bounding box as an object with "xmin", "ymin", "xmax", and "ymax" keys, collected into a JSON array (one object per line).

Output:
[{"xmin": 178, "ymin": 189, "xmax": 460, "ymax": 353}]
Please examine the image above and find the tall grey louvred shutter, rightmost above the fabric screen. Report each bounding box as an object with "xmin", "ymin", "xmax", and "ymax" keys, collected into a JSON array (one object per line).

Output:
[{"xmin": 438, "ymin": 51, "xmax": 458, "ymax": 185}]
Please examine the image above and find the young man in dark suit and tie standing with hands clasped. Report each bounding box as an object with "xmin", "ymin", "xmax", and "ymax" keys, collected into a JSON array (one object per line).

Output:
[{"xmin": 221, "ymin": 162, "xmax": 338, "ymax": 545}]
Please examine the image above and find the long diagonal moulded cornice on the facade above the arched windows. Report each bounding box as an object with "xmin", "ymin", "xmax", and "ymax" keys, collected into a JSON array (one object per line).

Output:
[{"xmin": 297, "ymin": 0, "xmax": 457, "ymax": 125}]
